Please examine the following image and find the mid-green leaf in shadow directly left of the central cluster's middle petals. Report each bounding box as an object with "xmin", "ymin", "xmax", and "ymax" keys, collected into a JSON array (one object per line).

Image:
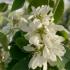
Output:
[{"xmin": 13, "ymin": 31, "xmax": 29, "ymax": 48}]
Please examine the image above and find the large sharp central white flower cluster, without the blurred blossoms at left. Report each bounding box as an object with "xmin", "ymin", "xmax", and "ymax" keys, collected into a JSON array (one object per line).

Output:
[{"xmin": 24, "ymin": 5, "xmax": 69, "ymax": 70}]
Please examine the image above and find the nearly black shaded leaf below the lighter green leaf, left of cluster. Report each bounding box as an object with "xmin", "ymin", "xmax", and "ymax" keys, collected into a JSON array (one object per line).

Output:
[{"xmin": 10, "ymin": 43, "xmax": 29, "ymax": 60}]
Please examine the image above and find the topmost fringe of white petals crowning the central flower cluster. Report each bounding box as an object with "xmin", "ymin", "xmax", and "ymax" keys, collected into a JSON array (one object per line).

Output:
[{"xmin": 32, "ymin": 5, "xmax": 53, "ymax": 17}]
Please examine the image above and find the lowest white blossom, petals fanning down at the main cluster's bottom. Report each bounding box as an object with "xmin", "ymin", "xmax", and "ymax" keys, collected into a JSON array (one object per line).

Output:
[{"xmin": 29, "ymin": 54, "xmax": 47, "ymax": 69}]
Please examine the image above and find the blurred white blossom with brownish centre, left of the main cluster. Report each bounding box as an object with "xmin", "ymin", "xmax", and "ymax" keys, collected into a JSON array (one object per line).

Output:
[{"xmin": 0, "ymin": 8, "xmax": 24, "ymax": 41}]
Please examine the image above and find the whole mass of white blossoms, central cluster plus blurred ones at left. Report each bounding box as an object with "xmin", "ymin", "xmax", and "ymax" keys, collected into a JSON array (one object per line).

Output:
[{"xmin": 2, "ymin": 5, "xmax": 68, "ymax": 70}]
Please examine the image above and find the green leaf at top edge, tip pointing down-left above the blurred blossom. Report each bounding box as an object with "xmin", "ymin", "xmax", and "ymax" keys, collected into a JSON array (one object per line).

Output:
[{"xmin": 11, "ymin": 0, "xmax": 25, "ymax": 11}]
